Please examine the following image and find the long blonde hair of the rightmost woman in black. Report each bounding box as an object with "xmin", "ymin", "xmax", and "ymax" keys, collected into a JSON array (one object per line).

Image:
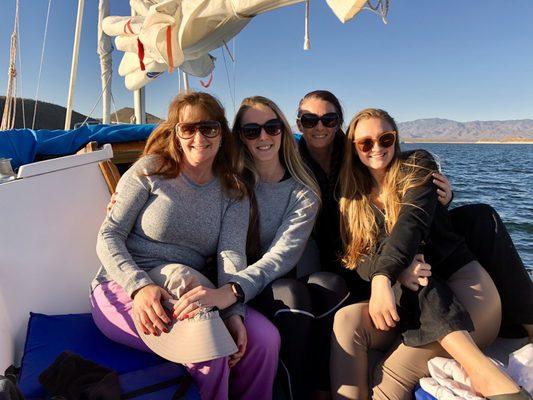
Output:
[{"xmin": 339, "ymin": 108, "xmax": 433, "ymax": 269}]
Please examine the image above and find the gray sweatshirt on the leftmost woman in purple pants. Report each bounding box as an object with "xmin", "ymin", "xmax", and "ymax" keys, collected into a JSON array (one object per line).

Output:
[{"xmin": 92, "ymin": 156, "xmax": 249, "ymax": 316}]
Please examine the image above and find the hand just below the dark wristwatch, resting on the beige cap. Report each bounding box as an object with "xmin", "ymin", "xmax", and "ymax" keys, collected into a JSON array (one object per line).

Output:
[{"xmin": 173, "ymin": 284, "xmax": 237, "ymax": 320}]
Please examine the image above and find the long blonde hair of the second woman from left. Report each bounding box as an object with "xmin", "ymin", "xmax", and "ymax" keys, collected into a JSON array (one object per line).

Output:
[{"xmin": 232, "ymin": 96, "xmax": 320, "ymax": 264}]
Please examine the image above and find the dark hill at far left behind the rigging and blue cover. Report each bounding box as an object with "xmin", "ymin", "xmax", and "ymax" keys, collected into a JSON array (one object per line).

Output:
[{"xmin": 0, "ymin": 96, "xmax": 161, "ymax": 129}]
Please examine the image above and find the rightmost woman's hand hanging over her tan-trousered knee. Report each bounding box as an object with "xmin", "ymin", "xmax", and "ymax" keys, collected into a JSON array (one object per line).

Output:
[{"xmin": 368, "ymin": 275, "xmax": 400, "ymax": 331}]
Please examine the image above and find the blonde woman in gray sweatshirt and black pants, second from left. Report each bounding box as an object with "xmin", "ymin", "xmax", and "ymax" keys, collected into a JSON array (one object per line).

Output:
[{"xmin": 233, "ymin": 96, "xmax": 347, "ymax": 399}]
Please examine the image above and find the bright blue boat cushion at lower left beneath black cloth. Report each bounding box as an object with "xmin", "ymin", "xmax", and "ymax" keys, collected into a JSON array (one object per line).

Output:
[{"xmin": 18, "ymin": 313, "xmax": 198, "ymax": 399}]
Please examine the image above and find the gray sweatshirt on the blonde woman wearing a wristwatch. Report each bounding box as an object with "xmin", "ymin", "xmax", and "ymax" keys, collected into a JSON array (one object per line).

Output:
[{"xmin": 227, "ymin": 178, "xmax": 319, "ymax": 301}]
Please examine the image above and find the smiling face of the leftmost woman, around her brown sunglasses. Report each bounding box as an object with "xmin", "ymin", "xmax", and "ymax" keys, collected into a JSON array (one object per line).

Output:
[{"xmin": 178, "ymin": 105, "xmax": 222, "ymax": 169}]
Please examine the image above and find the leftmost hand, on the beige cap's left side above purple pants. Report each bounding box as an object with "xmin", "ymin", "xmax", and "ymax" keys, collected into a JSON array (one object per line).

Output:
[{"xmin": 133, "ymin": 283, "xmax": 172, "ymax": 336}]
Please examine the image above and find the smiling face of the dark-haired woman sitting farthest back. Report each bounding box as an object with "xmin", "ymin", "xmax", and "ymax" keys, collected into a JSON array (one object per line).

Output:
[{"xmin": 298, "ymin": 97, "xmax": 339, "ymax": 149}]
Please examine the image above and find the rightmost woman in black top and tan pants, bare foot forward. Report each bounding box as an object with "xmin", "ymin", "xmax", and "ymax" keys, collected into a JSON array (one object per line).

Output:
[{"xmin": 332, "ymin": 109, "xmax": 520, "ymax": 399}]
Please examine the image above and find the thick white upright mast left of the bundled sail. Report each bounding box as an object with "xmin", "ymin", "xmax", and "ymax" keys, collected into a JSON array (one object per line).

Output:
[{"xmin": 97, "ymin": 0, "xmax": 113, "ymax": 124}]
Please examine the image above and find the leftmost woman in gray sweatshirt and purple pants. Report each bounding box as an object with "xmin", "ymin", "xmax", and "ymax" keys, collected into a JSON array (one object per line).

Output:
[{"xmin": 91, "ymin": 93, "xmax": 279, "ymax": 400}]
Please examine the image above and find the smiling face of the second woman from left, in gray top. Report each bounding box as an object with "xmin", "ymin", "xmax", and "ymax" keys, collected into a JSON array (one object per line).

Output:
[{"xmin": 241, "ymin": 104, "xmax": 284, "ymax": 163}]
